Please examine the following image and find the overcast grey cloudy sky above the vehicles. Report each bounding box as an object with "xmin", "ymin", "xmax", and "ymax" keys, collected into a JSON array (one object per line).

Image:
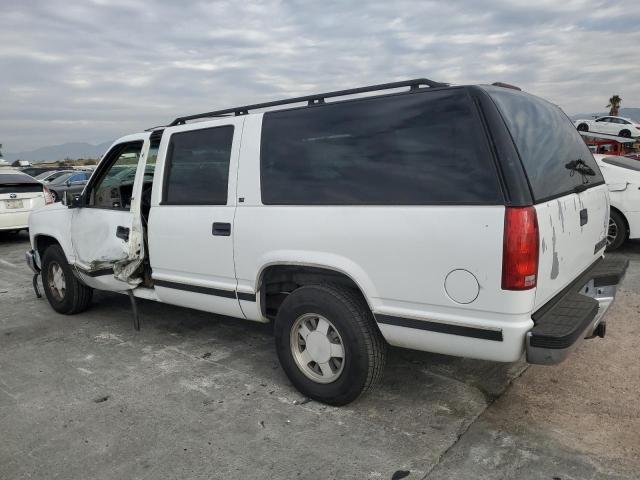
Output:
[{"xmin": 0, "ymin": 0, "xmax": 640, "ymax": 152}]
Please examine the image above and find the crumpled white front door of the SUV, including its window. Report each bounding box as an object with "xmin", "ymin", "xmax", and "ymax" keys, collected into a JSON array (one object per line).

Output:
[{"xmin": 71, "ymin": 135, "xmax": 153, "ymax": 291}]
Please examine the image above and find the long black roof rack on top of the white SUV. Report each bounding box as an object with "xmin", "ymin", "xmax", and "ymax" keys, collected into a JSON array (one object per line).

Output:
[{"xmin": 167, "ymin": 78, "xmax": 448, "ymax": 127}]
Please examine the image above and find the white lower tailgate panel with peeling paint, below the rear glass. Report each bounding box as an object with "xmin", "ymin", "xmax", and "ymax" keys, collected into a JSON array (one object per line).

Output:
[{"xmin": 534, "ymin": 185, "xmax": 609, "ymax": 309}]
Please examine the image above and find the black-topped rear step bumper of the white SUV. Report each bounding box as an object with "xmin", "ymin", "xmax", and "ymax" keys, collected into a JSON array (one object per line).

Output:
[{"xmin": 526, "ymin": 258, "xmax": 629, "ymax": 365}]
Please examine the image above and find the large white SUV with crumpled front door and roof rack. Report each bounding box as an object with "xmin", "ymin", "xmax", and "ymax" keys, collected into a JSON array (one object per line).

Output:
[{"xmin": 27, "ymin": 79, "xmax": 627, "ymax": 405}]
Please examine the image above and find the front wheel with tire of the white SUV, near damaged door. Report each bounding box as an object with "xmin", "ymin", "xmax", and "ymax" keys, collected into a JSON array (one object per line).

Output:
[{"xmin": 42, "ymin": 245, "xmax": 93, "ymax": 315}]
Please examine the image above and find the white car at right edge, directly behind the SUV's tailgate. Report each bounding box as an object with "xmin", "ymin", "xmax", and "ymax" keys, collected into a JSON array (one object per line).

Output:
[{"xmin": 594, "ymin": 155, "xmax": 640, "ymax": 250}]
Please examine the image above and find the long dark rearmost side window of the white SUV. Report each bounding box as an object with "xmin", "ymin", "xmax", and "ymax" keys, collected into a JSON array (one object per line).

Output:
[{"xmin": 261, "ymin": 89, "xmax": 503, "ymax": 205}]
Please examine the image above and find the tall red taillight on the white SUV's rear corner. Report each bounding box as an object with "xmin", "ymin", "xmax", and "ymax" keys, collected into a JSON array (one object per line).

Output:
[{"xmin": 502, "ymin": 207, "xmax": 538, "ymax": 290}]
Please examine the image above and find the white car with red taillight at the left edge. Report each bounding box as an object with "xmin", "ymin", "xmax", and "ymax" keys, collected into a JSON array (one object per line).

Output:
[{"xmin": 0, "ymin": 170, "xmax": 53, "ymax": 232}]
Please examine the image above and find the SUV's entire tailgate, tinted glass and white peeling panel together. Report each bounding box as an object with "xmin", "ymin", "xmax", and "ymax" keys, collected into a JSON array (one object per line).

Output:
[{"xmin": 484, "ymin": 87, "xmax": 609, "ymax": 310}]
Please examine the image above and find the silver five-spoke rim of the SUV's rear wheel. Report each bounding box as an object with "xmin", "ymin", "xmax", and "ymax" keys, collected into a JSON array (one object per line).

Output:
[{"xmin": 290, "ymin": 313, "xmax": 345, "ymax": 383}]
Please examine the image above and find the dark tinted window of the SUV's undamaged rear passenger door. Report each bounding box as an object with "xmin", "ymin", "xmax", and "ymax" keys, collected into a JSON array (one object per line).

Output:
[{"xmin": 162, "ymin": 125, "xmax": 233, "ymax": 205}]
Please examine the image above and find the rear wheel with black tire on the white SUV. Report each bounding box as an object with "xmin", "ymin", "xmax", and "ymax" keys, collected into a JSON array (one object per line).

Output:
[{"xmin": 274, "ymin": 284, "xmax": 386, "ymax": 405}]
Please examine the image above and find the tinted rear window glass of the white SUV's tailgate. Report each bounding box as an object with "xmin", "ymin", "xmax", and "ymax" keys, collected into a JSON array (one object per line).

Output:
[{"xmin": 485, "ymin": 87, "xmax": 604, "ymax": 202}]
